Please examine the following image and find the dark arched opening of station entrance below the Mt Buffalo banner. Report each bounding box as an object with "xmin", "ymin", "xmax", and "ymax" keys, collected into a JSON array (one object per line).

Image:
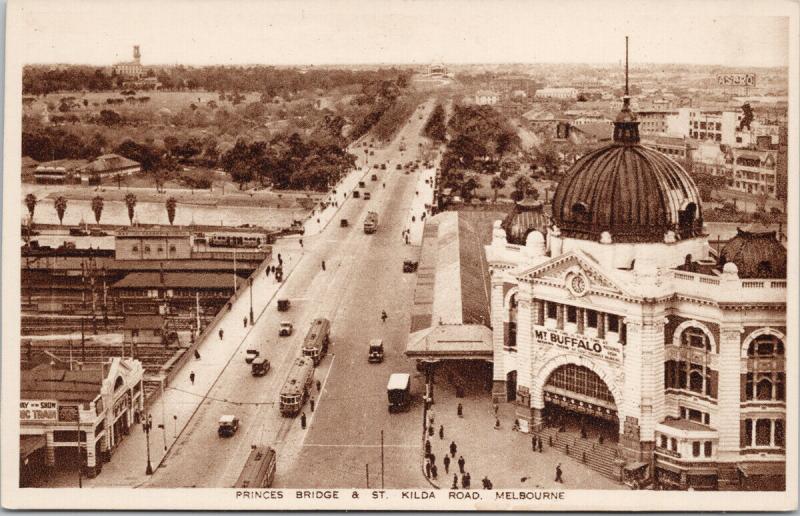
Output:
[{"xmin": 543, "ymin": 364, "xmax": 619, "ymax": 442}]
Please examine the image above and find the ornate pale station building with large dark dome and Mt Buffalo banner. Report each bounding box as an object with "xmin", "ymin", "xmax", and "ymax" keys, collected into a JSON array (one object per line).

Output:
[{"xmin": 485, "ymin": 82, "xmax": 787, "ymax": 490}]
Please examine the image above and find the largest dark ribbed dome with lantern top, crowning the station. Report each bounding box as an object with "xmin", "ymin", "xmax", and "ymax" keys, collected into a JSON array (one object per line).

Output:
[{"xmin": 552, "ymin": 104, "xmax": 703, "ymax": 242}]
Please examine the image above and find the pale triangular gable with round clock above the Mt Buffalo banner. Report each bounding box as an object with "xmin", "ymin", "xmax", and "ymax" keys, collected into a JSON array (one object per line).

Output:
[{"xmin": 517, "ymin": 249, "xmax": 631, "ymax": 297}]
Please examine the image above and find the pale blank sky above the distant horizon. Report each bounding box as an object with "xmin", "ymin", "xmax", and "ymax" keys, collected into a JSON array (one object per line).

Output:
[{"xmin": 8, "ymin": 0, "xmax": 796, "ymax": 66}]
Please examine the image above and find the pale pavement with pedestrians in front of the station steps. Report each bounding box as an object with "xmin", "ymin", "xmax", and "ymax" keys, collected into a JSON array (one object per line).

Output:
[{"xmin": 416, "ymin": 362, "xmax": 626, "ymax": 489}]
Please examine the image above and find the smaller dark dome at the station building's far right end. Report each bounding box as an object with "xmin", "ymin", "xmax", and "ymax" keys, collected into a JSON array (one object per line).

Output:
[{"xmin": 718, "ymin": 229, "xmax": 786, "ymax": 278}]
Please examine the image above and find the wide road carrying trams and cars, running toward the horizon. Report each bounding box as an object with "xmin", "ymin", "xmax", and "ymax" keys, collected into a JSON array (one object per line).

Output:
[{"xmin": 146, "ymin": 98, "xmax": 433, "ymax": 487}]
